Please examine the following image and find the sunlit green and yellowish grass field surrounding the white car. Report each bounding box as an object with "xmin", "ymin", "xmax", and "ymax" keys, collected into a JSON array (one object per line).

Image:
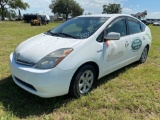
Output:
[{"xmin": 0, "ymin": 22, "xmax": 160, "ymax": 120}]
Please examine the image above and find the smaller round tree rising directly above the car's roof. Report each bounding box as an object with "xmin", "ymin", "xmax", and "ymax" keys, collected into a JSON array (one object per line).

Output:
[{"xmin": 102, "ymin": 3, "xmax": 122, "ymax": 14}]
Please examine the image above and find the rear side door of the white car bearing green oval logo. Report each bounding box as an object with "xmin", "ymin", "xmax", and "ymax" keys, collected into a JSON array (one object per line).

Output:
[{"xmin": 127, "ymin": 17, "xmax": 145, "ymax": 63}]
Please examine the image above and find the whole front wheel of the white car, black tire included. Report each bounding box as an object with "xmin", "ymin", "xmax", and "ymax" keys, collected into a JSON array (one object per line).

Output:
[{"xmin": 69, "ymin": 65, "xmax": 96, "ymax": 98}]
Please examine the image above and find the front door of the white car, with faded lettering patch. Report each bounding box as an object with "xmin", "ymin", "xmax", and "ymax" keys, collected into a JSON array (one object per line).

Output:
[{"xmin": 103, "ymin": 17, "xmax": 129, "ymax": 75}]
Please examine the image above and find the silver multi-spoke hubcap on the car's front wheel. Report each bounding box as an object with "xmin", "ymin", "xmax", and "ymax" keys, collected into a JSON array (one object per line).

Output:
[{"xmin": 79, "ymin": 70, "xmax": 94, "ymax": 94}]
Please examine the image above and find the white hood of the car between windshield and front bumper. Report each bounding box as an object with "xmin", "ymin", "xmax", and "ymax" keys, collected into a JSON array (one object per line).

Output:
[{"xmin": 15, "ymin": 34, "xmax": 82, "ymax": 63}]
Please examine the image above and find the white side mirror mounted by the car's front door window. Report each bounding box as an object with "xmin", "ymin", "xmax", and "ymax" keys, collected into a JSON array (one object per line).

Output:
[{"xmin": 105, "ymin": 32, "xmax": 121, "ymax": 41}]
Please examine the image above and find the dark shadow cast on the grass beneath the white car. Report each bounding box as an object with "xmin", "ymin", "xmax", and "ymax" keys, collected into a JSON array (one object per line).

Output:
[{"xmin": 0, "ymin": 63, "xmax": 138, "ymax": 119}]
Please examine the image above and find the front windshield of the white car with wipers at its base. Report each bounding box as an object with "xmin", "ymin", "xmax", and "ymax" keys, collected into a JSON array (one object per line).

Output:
[{"xmin": 46, "ymin": 17, "xmax": 108, "ymax": 39}]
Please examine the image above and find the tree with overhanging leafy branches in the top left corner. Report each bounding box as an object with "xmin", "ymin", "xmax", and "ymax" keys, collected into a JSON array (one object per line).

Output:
[{"xmin": 0, "ymin": 0, "xmax": 29, "ymax": 20}]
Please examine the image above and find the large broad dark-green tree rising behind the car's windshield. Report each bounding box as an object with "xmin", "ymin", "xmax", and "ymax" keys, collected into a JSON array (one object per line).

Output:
[{"xmin": 49, "ymin": 0, "xmax": 84, "ymax": 20}]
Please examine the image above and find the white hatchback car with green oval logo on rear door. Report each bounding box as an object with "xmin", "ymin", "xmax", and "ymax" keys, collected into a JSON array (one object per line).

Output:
[{"xmin": 10, "ymin": 14, "xmax": 152, "ymax": 98}]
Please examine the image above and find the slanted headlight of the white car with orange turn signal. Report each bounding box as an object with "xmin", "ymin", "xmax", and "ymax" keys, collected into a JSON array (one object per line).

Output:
[{"xmin": 35, "ymin": 48, "xmax": 73, "ymax": 69}]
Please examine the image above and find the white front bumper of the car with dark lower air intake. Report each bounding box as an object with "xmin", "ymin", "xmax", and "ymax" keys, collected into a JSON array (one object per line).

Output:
[{"xmin": 10, "ymin": 53, "xmax": 75, "ymax": 98}]
